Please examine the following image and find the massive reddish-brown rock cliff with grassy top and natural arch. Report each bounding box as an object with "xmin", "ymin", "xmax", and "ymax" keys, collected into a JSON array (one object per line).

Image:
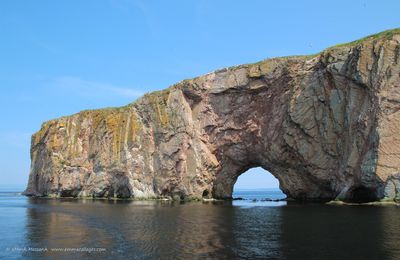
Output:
[{"xmin": 25, "ymin": 29, "xmax": 400, "ymax": 200}]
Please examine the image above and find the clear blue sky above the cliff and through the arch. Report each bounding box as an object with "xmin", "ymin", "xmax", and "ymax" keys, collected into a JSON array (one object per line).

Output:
[{"xmin": 0, "ymin": 0, "xmax": 400, "ymax": 188}]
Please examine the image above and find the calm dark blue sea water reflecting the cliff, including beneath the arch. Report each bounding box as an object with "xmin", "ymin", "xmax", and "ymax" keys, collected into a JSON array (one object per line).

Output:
[{"xmin": 0, "ymin": 190, "xmax": 400, "ymax": 259}]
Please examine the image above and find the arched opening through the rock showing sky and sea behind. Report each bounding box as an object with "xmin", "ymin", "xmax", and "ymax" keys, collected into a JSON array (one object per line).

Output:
[{"xmin": 232, "ymin": 167, "xmax": 286, "ymax": 200}]
